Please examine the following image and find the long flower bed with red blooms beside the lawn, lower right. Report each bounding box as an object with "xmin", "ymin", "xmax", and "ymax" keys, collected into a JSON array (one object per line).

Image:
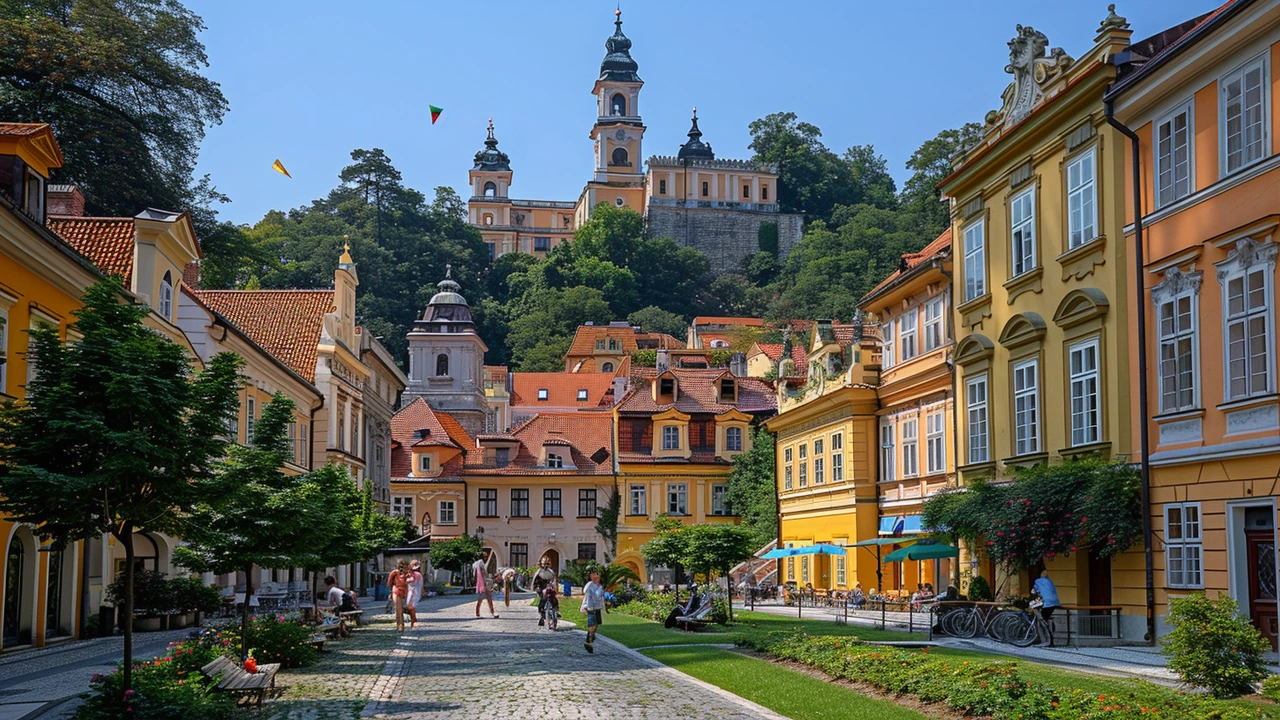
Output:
[{"xmin": 739, "ymin": 633, "xmax": 1280, "ymax": 720}]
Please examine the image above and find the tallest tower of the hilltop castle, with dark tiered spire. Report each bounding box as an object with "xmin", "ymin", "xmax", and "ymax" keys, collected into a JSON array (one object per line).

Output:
[{"xmin": 575, "ymin": 10, "xmax": 645, "ymax": 225}]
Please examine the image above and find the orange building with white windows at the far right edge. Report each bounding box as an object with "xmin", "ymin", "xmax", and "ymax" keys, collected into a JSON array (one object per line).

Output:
[{"xmin": 1107, "ymin": 0, "xmax": 1280, "ymax": 647}]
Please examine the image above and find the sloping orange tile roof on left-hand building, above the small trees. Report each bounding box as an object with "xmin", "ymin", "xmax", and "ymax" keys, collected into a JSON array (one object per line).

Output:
[{"xmin": 191, "ymin": 290, "xmax": 333, "ymax": 383}]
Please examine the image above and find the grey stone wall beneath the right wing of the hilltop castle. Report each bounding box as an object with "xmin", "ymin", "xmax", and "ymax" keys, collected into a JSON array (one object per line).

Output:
[{"xmin": 645, "ymin": 205, "xmax": 804, "ymax": 274}]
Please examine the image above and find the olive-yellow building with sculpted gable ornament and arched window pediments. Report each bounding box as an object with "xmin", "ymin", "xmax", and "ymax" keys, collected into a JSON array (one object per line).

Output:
[{"xmin": 941, "ymin": 13, "xmax": 1146, "ymax": 637}]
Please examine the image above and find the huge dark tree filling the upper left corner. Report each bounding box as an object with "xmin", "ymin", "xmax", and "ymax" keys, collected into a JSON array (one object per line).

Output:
[{"xmin": 0, "ymin": 0, "xmax": 228, "ymax": 217}]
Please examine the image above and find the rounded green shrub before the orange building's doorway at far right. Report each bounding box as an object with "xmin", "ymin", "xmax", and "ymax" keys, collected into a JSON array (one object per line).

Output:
[{"xmin": 1164, "ymin": 593, "xmax": 1271, "ymax": 697}]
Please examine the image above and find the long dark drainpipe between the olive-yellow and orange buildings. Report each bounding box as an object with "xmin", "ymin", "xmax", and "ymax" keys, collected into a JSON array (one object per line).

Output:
[{"xmin": 1105, "ymin": 100, "xmax": 1156, "ymax": 644}]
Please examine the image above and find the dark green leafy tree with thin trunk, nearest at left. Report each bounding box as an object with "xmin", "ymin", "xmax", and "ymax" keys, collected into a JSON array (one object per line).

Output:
[{"xmin": 0, "ymin": 281, "xmax": 241, "ymax": 688}]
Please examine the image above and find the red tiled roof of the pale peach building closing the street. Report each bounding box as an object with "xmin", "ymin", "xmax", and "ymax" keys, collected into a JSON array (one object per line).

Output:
[{"xmin": 467, "ymin": 413, "xmax": 613, "ymax": 475}]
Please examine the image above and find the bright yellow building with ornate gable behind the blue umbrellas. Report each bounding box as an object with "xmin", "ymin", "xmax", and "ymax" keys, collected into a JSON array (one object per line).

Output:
[{"xmin": 765, "ymin": 320, "xmax": 879, "ymax": 591}]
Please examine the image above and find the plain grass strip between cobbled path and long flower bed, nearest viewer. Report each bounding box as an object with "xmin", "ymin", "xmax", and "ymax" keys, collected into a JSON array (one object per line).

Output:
[{"xmin": 641, "ymin": 645, "xmax": 924, "ymax": 720}]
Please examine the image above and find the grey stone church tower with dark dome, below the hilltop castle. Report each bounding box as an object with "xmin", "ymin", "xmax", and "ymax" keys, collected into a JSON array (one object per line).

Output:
[{"xmin": 404, "ymin": 268, "xmax": 489, "ymax": 436}]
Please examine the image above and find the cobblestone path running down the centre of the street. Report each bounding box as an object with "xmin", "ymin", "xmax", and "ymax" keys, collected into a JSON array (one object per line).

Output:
[{"xmin": 362, "ymin": 596, "xmax": 778, "ymax": 720}]
